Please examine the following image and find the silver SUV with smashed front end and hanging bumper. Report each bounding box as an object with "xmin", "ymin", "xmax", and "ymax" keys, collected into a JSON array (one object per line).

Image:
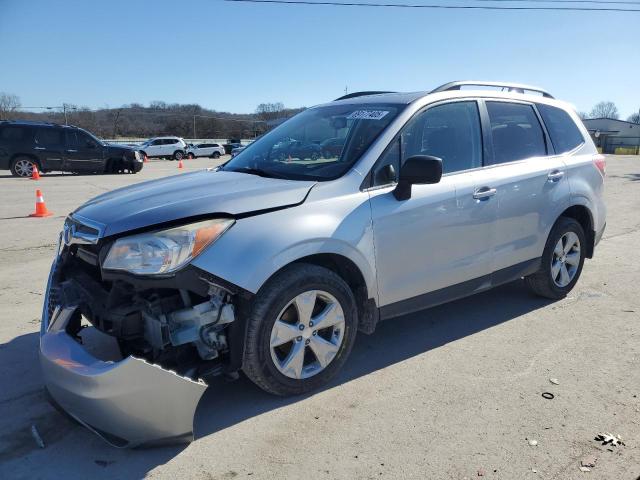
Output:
[{"xmin": 40, "ymin": 82, "xmax": 605, "ymax": 446}]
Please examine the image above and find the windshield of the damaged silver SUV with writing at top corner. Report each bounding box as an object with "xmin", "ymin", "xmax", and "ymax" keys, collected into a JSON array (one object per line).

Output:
[{"xmin": 222, "ymin": 104, "xmax": 399, "ymax": 181}]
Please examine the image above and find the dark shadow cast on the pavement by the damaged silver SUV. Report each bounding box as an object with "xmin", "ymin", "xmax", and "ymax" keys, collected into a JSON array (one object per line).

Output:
[{"xmin": 0, "ymin": 281, "xmax": 550, "ymax": 479}]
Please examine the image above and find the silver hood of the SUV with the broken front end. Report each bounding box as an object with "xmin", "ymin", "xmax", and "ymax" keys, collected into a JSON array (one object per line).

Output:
[{"xmin": 73, "ymin": 170, "xmax": 315, "ymax": 236}]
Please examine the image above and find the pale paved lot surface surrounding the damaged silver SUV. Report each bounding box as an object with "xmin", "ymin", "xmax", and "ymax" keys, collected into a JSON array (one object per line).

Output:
[{"xmin": 0, "ymin": 156, "xmax": 640, "ymax": 480}]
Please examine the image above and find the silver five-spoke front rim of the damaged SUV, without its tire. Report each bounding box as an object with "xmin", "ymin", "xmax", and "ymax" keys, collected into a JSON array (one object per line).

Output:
[{"xmin": 270, "ymin": 290, "xmax": 345, "ymax": 380}]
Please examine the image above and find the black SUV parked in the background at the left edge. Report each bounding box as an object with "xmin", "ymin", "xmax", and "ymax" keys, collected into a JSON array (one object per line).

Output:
[{"xmin": 0, "ymin": 121, "xmax": 142, "ymax": 177}]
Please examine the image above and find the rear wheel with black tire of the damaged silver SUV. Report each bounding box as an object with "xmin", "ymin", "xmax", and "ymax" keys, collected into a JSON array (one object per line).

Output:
[{"xmin": 525, "ymin": 217, "xmax": 587, "ymax": 300}]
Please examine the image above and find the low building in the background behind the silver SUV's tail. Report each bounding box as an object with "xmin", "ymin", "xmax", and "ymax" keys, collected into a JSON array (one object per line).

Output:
[{"xmin": 583, "ymin": 118, "xmax": 640, "ymax": 155}]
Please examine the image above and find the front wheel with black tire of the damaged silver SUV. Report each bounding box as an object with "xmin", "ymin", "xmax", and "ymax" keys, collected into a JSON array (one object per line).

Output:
[{"xmin": 242, "ymin": 263, "xmax": 358, "ymax": 395}]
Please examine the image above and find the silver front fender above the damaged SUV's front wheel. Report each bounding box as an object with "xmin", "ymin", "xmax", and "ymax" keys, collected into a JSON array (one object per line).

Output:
[{"xmin": 193, "ymin": 192, "xmax": 377, "ymax": 300}]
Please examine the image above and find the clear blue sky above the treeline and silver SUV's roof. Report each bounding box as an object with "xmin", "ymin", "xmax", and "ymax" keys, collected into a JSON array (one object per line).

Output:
[{"xmin": 0, "ymin": 0, "xmax": 640, "ymax": 118}]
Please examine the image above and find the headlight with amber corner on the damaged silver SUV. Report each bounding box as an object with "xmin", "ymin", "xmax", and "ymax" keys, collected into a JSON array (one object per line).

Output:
[{"xmin": 102, "ymin": 218, "xmax": 234, "ymax": 275}]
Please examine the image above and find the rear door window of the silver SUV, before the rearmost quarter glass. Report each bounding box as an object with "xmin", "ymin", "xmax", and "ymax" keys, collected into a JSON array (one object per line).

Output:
[{"xmin": 487, "ymin": 102, "xmax": 547, "ymax": 163}]
